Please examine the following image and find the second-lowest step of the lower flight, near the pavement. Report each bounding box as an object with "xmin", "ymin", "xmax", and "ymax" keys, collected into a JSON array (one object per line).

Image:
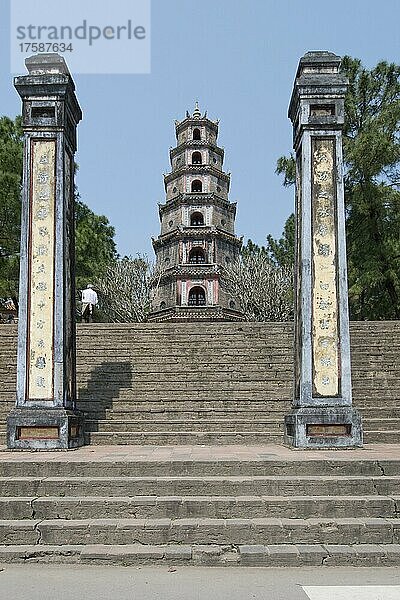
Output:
[{"xmin": 0, "ymin": 517, "xmax": 400, "ymax": 545}]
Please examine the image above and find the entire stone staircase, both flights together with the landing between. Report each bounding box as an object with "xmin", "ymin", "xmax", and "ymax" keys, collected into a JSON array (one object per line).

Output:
[{"xmin": 0, "ymin": 322, "xmax": 400, "ymax": 566}]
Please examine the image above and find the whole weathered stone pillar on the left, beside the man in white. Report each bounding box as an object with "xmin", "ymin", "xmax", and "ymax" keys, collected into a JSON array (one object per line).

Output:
[{"xmin": 7, "ymin": 54, "xmax": 83, "ymax": 450}]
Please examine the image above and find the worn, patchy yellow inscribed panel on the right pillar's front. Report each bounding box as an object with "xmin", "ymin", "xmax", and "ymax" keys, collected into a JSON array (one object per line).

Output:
[{"xmin": 312, "ymin": 138, "xmax": 340, "ymax": 396}]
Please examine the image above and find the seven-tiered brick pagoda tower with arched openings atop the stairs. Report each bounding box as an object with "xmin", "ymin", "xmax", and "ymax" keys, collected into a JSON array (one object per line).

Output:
[{"xmin": 150, "ymin": 103, "xmax": 243, "ymax": 321}]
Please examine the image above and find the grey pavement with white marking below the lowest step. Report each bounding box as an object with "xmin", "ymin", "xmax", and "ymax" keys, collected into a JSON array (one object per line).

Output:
[{"xmin": 0, "ymin": 565, "xmax": 400, "ymax": 600}]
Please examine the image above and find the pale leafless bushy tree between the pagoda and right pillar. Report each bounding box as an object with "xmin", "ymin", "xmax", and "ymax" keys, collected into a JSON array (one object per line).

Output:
[{"xmin": 221, "ymin": 251, "xmax": 293, "ymax": 321}]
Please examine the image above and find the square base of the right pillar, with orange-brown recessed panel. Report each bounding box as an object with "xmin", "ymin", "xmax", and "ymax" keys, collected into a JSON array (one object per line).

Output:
[{"xmin": 285, "ymin": 406, "xmax": 363, "ymax": 449}]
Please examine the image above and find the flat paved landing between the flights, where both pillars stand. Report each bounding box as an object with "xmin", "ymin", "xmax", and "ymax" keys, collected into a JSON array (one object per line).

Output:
[{"xmin": 0, "ymin": 444, "xmax": 400, "ymax": 462}]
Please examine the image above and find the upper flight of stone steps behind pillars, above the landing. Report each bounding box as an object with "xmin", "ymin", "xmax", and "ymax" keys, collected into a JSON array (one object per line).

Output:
[{"xmin": 0, "ymin": 322, "xmax": 400, "ymax": 445}]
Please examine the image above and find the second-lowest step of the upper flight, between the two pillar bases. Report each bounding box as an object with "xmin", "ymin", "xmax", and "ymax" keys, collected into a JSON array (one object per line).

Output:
[{"xmin": 85, "ymin": 417, "xmax": 284, "ymax": 436}]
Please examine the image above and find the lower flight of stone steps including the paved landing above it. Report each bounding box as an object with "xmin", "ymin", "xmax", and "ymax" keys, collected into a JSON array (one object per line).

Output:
[{"xmin": 0, "ymin": 446, "xmax": 400, "ymax": 566}]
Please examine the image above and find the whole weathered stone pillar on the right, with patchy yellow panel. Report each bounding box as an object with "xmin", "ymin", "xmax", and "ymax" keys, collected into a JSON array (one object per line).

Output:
[{"xmin": 285, "ymin": 52, "xmax": 362, "ymax": 448}]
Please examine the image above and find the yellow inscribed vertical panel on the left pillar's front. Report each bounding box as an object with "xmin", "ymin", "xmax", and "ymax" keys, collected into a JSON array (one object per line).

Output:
[{"xmin": 27, "ymin": 140, "xmax": 55, "ymax": 400}]
